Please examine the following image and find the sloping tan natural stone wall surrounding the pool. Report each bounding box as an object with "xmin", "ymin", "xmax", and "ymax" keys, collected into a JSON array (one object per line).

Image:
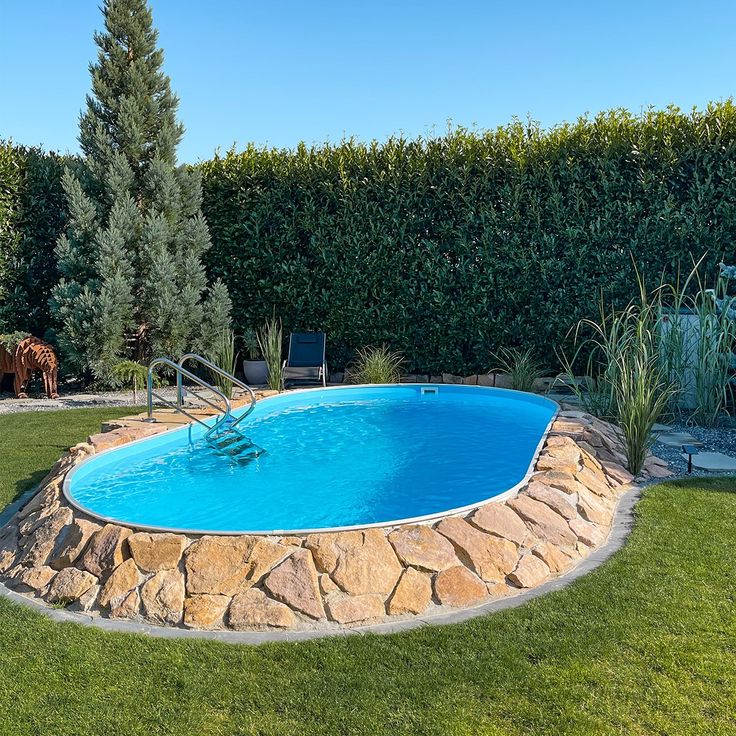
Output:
[{"xmin": 0, "ymin": 410, "xmax": 667, "ymax": 630}]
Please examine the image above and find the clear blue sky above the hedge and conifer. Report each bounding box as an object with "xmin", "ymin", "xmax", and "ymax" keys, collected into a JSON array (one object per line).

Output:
[{"xmin": 0, "ymin": 0, "xmax": 736, "ymax": 162}]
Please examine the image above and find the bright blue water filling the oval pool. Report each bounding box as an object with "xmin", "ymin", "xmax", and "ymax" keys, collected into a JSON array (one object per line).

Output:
[{"xmin": 66, "ymin": 385, "xmax": 556, "ymax": 533}]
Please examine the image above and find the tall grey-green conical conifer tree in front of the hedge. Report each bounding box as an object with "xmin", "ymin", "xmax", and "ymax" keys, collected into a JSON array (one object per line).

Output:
[{"xmin": 51, "ymin": 0, "xmax": 231, "ymax": 384}]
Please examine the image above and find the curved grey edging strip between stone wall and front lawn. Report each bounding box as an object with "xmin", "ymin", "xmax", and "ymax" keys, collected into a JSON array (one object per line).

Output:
[{"xmin": 0, "ymin": 486, "xmax": 643, "ymax": 645}]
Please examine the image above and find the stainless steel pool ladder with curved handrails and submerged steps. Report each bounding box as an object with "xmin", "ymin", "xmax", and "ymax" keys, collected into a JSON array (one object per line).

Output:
[{"xmin": 147, "ymin": 353, "xmax": 263, "ymax": 461}]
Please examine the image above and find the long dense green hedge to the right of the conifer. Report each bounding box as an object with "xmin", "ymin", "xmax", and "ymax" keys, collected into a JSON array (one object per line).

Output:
[{"xmin": 199, "ymin": 101, "xmax": 736, "ymax": 372}]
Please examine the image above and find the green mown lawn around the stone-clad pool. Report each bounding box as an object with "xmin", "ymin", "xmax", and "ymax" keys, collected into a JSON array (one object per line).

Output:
[{"xmin": 0, "ymin": 410, "xmax": 736, "ymax": 736}]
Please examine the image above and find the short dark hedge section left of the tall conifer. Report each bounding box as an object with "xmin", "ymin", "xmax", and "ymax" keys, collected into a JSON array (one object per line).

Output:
[{"xmin": 0, "ymin": 141, "xmax": 69, "ymax": 336}]
